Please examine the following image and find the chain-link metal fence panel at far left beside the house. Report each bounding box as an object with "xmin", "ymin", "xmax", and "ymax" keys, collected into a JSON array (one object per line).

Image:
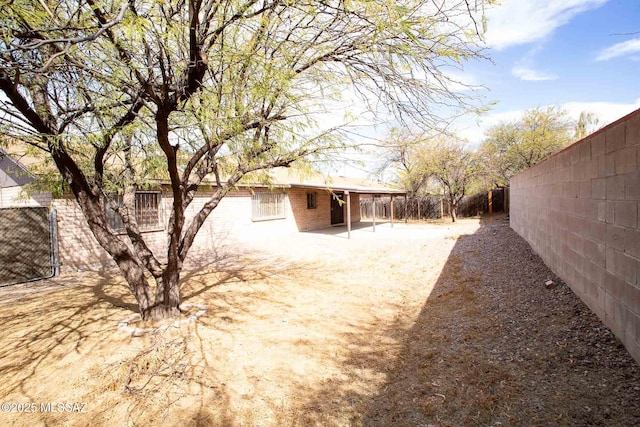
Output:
[{"xmin": 0, "ymin": 207, "xmax": 60, "ymax": 286}]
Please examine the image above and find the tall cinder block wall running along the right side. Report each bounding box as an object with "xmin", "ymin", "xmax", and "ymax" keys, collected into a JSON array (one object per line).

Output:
[{"xmin": 510, "ymin": 110, "xmax": 640, "ymax": 363}]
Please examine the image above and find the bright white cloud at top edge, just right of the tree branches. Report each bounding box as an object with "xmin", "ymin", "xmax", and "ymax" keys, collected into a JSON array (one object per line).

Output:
[{"xmin": 486, "ymin": 0, "xmax": 608, "ymax": 50}]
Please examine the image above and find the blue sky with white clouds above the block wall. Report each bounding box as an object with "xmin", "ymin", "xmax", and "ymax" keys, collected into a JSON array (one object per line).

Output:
[{"xmin": 336, "ymin": 0, "xmax": 640, "ymax": 179}]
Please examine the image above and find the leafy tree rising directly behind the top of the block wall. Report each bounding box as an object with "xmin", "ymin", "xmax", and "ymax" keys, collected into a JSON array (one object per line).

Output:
[{"xmin": 480, "ymin": 107, "xmax": 574, "ymax": 186}]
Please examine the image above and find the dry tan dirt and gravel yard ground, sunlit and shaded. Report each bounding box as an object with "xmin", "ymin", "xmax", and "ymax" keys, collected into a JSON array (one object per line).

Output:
[{"xmin": 0, "ymin": 216, "xmax": 640, "ymax": 426}]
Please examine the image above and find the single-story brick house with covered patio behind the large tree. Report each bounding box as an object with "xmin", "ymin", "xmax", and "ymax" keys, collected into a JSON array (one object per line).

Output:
[{"xmin": 0, "ymin": 152, "xmax": 406, "ymax": 271}]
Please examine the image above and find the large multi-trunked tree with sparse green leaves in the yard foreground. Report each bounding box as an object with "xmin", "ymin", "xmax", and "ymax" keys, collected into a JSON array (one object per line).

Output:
[{"xmin": 0, "ymin": 0, "xmax": 484, "ymax": 319}]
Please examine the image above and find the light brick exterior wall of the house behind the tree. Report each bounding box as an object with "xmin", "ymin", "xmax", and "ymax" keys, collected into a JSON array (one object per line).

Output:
[{"xmin": 52, "ymin": 188, "xmax": 360, "ymax": 272}]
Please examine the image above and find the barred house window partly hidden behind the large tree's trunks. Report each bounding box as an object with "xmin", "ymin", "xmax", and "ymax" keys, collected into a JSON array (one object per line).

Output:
[{"xmin": 105, "ymin": 191, "xmax": 162, "ymax": 231}]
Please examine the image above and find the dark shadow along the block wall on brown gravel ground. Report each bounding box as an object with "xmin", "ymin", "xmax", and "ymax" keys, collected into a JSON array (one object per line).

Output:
[{"xmin": 295, "ymin": 216, "xmax": 640, "ymax": 426}]
